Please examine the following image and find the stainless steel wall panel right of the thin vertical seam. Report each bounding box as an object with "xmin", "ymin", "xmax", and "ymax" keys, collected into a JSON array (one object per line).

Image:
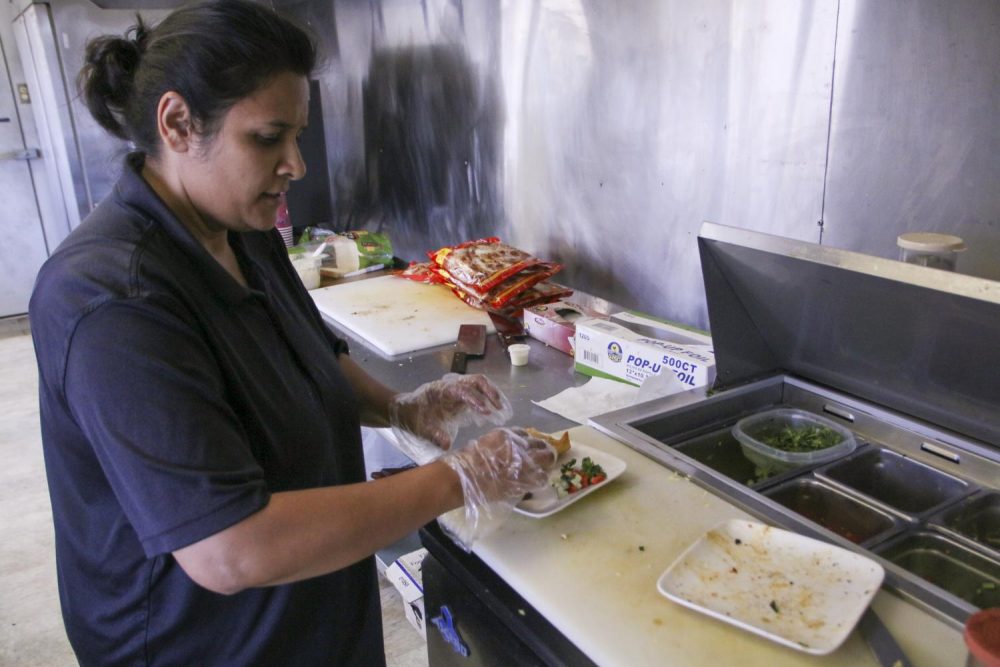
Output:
[{"xmin": 824, "ymin": 0, "xmax": 1000, "ymax": 280}]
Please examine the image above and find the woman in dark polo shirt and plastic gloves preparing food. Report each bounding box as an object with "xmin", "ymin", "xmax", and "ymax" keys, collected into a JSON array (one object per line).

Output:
[{"xmin": 30, "ymin": 0, "xmax": 555, "ymax": 665}]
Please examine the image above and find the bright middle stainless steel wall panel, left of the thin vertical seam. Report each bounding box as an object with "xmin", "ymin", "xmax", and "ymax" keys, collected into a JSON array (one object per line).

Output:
[{"xmin": 502, "ymin": 0, "xmax": 836, "ymax": 326}]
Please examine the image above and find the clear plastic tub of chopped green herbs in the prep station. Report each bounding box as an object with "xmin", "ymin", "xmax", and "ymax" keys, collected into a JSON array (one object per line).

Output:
[{"xmin": 733, "ymin": 408, "xmax": 857, "ymax": 474}]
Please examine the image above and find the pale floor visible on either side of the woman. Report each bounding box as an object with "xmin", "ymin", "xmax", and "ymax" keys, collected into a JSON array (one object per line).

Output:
[{"xmin": 0, "ymin": 318, "xmax": 427, "ymax": 667}]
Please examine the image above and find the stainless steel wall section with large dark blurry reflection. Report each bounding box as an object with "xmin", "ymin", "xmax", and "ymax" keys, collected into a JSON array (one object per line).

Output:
[{"xmin": 308, "ymin": 0, "xmax": 503, "ymax": 259}]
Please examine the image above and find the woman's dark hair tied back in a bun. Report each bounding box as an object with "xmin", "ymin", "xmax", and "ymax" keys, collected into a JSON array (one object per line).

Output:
[{"xmin": 77, "ymin": 0, "xmax": 316, "ymax": 157}]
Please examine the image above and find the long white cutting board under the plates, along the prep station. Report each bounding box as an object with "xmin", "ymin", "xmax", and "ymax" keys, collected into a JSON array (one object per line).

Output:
[{"xmin": 473, "ymin": 426, "xmax": 900, "ymax": 667}]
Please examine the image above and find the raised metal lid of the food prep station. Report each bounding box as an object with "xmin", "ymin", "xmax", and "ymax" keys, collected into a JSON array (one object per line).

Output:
[{"xmin": 698, "ymin": 223, "xmax": 1000, "ymax": 449}]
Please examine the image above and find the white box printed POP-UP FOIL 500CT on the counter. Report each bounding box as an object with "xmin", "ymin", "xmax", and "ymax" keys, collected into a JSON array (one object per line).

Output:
[{"xmin": 573, "ymin": 313, "xmax": 715, "ymax": 389}]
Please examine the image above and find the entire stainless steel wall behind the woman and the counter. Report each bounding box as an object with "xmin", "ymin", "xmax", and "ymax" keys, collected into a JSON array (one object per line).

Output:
[{"xmin": 19, "ymin": 0, "xmax": 1000, "ymax": 334}]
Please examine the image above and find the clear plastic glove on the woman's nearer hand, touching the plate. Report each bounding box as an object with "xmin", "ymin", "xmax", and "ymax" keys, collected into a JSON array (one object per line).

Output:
[{"xmin": 438, "ymin": 428, "xmax": 558, "ymax": 551}]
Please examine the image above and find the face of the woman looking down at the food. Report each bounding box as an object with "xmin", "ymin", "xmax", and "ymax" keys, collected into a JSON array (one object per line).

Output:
[{"xmin": 181, "ymin": 72, "xmax": 309, "ymax": 233}]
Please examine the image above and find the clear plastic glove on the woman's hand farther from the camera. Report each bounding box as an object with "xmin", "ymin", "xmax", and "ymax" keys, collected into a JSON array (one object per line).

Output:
[{"xmin": 389, "ymin": 373, "xmax": 514, "ymax": 464}]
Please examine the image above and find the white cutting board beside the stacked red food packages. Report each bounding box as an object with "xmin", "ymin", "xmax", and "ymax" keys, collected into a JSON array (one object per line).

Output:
[{"xmin": 309, "ymin": 276, "xmax": 496, "ymax": 356}]
